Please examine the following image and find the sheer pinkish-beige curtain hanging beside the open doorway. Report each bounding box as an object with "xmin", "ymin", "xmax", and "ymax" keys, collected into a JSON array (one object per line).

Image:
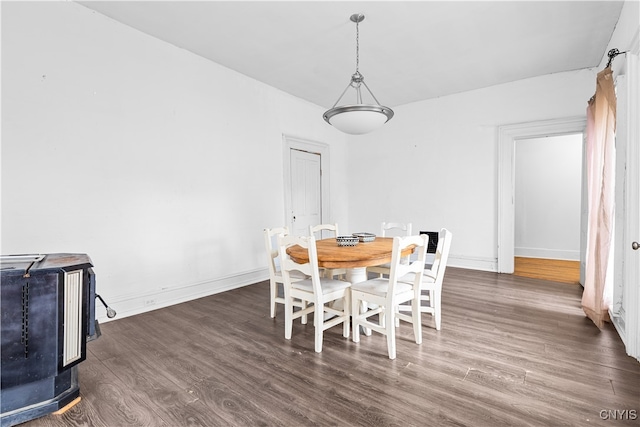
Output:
[{"xmin": 582, "ymin": 67, "xmax": 616, "ymax": 328}]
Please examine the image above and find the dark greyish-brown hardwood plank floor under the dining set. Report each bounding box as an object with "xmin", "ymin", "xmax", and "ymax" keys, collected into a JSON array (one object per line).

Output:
[{"xmin": 23, "ymin": 268, "xmax": 640, "ymax": 427}]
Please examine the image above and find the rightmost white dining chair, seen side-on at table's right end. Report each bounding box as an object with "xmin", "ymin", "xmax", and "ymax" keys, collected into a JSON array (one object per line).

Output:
[{"xmin": 398, "ymin": 228, "xmax": 453, "ymax": 331}]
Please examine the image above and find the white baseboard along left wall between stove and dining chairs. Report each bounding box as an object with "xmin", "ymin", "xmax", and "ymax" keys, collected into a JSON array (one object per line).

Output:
[{"xmin": 96, "ymin": 268, "xmax": 269, "ymax": 323}]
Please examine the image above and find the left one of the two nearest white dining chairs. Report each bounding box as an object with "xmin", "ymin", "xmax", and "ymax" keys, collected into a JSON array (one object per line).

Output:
[{"xmin": 278, "ymin": 234, "xmax": 351, "ymax": 353}]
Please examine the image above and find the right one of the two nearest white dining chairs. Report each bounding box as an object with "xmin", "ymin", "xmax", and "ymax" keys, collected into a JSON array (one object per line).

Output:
[{"xmin": 351, "ymin": 235, "xmax": 427, "ymax": 359}]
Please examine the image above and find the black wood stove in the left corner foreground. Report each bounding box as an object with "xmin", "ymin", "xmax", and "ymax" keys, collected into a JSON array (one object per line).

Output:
[{"xmin": 0, "ymin": 254, "xmax": 99, "ymax": 427}]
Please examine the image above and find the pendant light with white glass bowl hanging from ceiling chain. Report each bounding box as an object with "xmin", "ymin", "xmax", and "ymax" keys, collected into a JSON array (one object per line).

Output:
[{"xmin": 323, "ymin": 13, "xmax": 393, "ymax": 135}]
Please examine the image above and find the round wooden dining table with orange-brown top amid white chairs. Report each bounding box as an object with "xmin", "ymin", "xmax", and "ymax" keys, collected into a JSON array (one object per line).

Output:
[{"xmin": 287, "ymin": 237, "xmax": 413, "ymax": 283}]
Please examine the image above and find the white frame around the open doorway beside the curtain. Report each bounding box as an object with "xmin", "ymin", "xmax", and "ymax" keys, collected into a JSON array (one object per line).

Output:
[{"xmin": 497, "ymin": 116, "xmax": 587, "ymax": 274}]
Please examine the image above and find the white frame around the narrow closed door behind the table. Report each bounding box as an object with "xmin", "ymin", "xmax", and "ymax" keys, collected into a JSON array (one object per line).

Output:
[{"xmin": 282, "ymin": 134, "xmax": 331, "ymax": 230}]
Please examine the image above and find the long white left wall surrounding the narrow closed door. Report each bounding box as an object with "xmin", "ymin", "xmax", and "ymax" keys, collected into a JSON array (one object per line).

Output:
[{"xmin": 1, "ymin": 2, "xmax": 348, "ymax": 321}]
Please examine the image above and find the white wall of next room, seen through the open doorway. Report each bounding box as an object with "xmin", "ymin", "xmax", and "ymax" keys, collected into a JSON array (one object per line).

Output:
[{"xmin": 514, "ymin": 134, "xmax": 582, "ymax": 261}]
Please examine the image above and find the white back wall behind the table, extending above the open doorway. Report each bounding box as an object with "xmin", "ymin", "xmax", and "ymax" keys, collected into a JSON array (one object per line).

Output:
[{"xmin": 349, "ymin": 70, "xmax": 597, "ymax": 271}]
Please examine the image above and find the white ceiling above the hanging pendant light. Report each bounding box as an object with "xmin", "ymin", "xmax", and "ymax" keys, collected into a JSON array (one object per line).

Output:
[{"xmin": 80, "ymin": 1, "xmax": 622, "ymax": 108}]
